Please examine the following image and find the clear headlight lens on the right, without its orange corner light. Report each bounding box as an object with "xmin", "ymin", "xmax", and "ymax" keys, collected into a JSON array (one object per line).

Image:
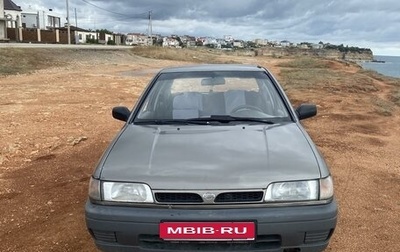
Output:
[{"xmin": 265, "ymin": 180, "xmax": 319, "ymax": 202}]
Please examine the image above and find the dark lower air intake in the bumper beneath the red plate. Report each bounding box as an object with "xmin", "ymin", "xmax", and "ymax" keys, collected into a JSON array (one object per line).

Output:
[{"xmin": 139, "ymin": 235, "xmax": 282, "ymax": 251}]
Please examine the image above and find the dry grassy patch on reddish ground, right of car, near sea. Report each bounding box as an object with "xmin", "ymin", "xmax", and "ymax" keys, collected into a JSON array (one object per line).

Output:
[{"xmin": 279, "ymin": 57, "xmax": 400, "ymax": 116}]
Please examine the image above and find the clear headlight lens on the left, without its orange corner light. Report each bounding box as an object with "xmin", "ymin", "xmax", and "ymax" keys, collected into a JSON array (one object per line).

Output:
[{"xmin": 103, "ymin": 182, "xmax": 154, "ymax": 203}]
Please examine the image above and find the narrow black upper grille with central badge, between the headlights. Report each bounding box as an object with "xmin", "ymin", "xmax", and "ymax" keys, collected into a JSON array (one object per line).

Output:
[{"xmin": 155, "ymin": 191, "xmax": 264, "ymax": 204}]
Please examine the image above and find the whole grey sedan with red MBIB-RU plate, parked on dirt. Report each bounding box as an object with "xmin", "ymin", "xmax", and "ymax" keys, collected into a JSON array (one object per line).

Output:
[{"xmin": 85, "ymin": 64, "xmax": 337, "ymax": 252}]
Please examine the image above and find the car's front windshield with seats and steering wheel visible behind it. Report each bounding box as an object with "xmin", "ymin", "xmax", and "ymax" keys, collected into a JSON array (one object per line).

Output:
[{"xmin": 135, "ymin": 71, "xmax": 289, "ymax": 122}]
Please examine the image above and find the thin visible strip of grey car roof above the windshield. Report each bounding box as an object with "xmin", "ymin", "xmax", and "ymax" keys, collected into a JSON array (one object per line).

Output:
[{"xmin": 160, "ymin": 64, "xmax": 266, "ymax": 73}]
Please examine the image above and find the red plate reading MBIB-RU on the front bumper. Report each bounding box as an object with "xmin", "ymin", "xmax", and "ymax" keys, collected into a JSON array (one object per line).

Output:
[{"xmin": 159, "ymin": 222, "xmax": 256, "ymax": 241}]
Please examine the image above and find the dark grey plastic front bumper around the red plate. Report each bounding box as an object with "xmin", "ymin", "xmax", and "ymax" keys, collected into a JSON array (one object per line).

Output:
[{"xmin": 86, "ymin": 200, "xmax": 337, "ymax": 252}]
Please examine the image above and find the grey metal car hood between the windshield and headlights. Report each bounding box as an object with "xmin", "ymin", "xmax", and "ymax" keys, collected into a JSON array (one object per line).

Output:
[{"xmin": 100, "ymin": 123, "xmax": 320, "ymax": 190}]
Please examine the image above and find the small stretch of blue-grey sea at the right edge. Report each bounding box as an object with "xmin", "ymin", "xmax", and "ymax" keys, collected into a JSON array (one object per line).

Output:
[{"xmin": 360, "ymin": 55, "xmax": 400, "ymax": 78}]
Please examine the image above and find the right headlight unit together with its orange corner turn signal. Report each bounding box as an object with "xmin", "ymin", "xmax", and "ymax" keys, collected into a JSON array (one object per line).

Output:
[{"xmin": 265, "ymin": 176, "xmax": 333, "ymax": 202}]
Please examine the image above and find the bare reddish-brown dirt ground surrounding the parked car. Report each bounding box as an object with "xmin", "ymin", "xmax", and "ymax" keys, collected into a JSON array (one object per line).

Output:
[{"xmin": 0, "ymin": 48, "xmax": 400, "ymax": 252}]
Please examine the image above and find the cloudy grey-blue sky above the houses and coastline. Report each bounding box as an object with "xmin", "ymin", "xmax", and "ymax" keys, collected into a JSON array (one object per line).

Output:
[{"xmin": 17, "ymin": 0, "xmax": 400, "ymax": 56}]
